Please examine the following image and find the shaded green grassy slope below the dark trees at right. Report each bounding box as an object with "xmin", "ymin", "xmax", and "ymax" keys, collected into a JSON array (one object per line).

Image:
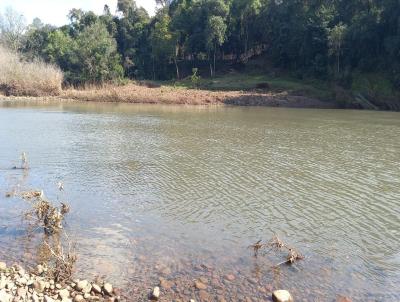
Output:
[{"xmin": 160, "ymin": 61, "xmax": 400, "ymax": 110}]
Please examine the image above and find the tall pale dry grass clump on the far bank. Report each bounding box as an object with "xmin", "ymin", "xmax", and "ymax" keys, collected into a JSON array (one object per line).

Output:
[{"xmin": 0, "ymin": 46, "xmax": 63, "ymax": 96}]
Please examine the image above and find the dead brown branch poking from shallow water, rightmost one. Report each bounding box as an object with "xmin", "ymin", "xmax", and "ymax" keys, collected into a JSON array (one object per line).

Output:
[{"xmin": 249, "ymin": 235, "xmax": 304, "ymax": 267}]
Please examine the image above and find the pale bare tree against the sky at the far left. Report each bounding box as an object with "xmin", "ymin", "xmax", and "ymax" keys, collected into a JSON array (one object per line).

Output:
[{"xmin": 0, "ymin": 7, "xmax": 26, "ymax": 52}]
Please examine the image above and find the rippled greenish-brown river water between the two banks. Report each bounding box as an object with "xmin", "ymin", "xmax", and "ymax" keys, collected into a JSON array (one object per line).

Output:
[{"xmin": 0, "ymin": 102, "xmax": 400, "ymax": 301}]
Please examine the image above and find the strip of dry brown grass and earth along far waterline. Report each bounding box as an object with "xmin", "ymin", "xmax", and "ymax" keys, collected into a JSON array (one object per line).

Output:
[{"xmin": 2, "ymin": 83, "xmax": 336, "ymax": 108}]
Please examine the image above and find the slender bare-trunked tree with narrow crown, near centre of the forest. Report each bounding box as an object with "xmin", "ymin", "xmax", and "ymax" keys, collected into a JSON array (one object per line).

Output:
[{"xmin": 206, "ymin": 16, "xmax": 226, "ymax": 76}]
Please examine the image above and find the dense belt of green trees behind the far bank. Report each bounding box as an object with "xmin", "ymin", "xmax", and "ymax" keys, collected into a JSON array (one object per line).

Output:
[{"xmin": 0, "ymin": 0, "xmax": 400, "ymax": 107}]
